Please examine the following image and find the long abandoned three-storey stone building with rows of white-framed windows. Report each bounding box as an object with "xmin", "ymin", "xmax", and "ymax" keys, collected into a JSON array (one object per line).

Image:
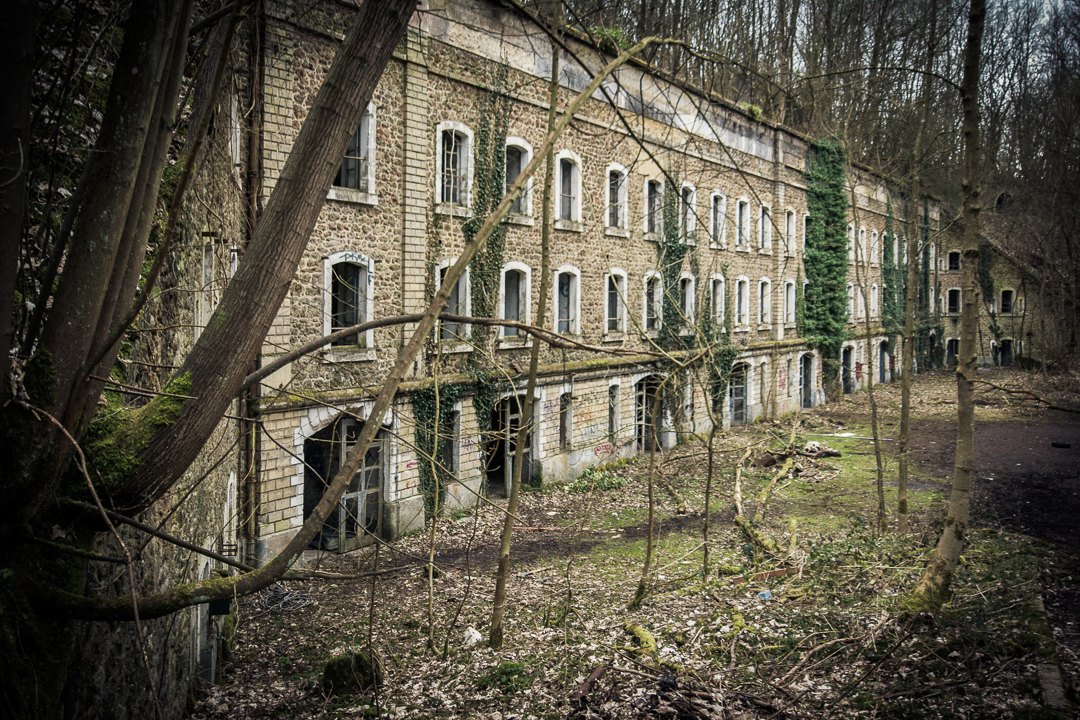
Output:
[{"xmin": 170, "ymin": 0, "xmax": 972, "ymax": 561}]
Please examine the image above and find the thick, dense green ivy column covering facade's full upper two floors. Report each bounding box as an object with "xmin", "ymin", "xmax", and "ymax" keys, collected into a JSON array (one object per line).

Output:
[{"xmin": 800, "ymin": 138, "xmax": 848, "ymax": 395}]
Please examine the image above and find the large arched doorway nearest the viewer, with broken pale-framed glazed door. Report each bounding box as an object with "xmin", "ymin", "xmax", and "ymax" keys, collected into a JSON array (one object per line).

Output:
[{"xmin": 303, "ymin": 418, "xmax": 388, "ymax": 553}]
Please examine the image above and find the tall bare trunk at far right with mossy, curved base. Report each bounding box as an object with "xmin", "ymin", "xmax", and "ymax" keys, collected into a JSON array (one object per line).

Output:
[{"xmin": 913, "ymin": 0, "xmax": 986, "ymax": 610}]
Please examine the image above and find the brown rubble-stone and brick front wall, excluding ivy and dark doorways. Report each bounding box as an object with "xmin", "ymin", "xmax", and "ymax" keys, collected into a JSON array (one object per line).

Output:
[{"xmin": 234, "ymin": 0, "xmax": 939, "ymax": 555}]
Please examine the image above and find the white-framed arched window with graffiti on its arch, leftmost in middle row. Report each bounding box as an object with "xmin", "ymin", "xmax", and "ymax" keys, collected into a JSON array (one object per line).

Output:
[{"xmin": 323, "ymin": 253, "xmax": 375, "ymax": 348}]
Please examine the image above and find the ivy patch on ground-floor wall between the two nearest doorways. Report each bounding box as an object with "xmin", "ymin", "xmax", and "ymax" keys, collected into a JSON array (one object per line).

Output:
[{"xmin": 411, "ymin": 383, "xmax": 468, "ymax": 519}]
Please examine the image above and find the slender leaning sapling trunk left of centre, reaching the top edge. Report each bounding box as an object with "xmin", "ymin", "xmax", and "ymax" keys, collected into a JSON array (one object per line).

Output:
[{"xmin": 487, "ymin": 2, "xmax": 562, "ymax": 650}]
